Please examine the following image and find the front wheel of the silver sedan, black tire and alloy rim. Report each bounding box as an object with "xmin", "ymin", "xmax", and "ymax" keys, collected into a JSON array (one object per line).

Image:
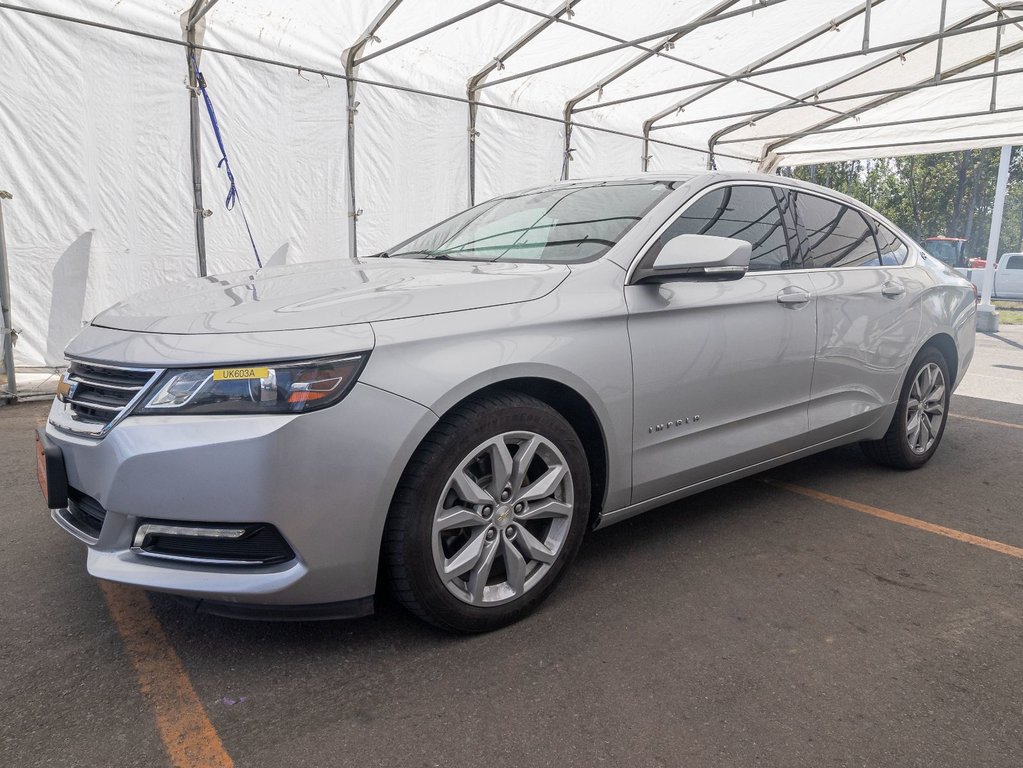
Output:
[{"xmin": 383, "ymin": 392, "xmax": 590, "ymax": 633}]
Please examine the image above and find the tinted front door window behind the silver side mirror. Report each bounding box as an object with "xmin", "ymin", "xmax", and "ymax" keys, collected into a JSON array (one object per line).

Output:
[{"xmin": 647, "ymin": 185, "xmax": 797, "ymax": 272}]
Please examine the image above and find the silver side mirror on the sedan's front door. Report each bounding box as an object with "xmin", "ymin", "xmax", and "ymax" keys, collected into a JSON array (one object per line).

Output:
[{"xmin": 633, "ymin": 234, "xmax": 753, "ymax": 282}]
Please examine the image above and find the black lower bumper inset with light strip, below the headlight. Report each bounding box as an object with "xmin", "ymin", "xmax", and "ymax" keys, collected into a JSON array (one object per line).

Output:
[{"xmin": 132, "ymin": 521, "xmax": 295, "ymax": 566}]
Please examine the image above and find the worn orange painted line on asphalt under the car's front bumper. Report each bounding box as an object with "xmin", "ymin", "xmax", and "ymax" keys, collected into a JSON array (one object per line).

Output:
[{"xmin": 100, "ymin": 582, "xmax": 234, "ymax": 768}]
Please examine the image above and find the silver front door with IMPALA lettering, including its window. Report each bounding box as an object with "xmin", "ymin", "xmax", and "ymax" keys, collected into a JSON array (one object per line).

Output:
[{"xmin": 625, "ymin": 184, "xmax": 816, "ymax": 503}]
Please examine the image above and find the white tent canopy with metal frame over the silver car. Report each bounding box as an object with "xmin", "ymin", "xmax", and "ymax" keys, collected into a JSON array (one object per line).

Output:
[{"xmin": 0, "ymin": 0, "xmax": 1023, "ymax": 366}]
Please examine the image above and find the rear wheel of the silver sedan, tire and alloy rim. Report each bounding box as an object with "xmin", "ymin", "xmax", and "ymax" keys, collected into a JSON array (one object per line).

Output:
[{"xmin": 859, "ymin": 347, "xmax": 951, "ymax": 469}]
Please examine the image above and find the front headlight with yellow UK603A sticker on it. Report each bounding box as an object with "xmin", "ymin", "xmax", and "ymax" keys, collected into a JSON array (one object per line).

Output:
[{"xmin": 135, "ymin": 355, "xmax": 367, "ymax": 415}]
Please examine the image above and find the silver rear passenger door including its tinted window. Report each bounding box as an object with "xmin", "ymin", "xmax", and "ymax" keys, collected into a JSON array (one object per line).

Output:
[{"xmin": 793, "ymin": 190, "xmax": 921, "ymax": 443}]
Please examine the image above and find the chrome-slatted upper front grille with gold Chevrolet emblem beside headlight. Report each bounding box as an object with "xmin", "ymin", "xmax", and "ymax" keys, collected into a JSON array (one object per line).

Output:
[{"xmin": 58, "ymin": 360, "xmax": 158, "ymax": 432}]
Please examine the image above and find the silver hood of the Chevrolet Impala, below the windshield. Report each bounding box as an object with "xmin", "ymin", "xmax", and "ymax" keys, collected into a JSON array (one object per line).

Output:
[{"xmin": 92, "ymin": 259, "xmax": 570, "ymax": 333}]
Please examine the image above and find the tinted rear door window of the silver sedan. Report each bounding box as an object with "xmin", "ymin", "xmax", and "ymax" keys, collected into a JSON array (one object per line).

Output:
[{"xmin": 796, "ymin": 192, "xmax": 881, "ymax": 268}]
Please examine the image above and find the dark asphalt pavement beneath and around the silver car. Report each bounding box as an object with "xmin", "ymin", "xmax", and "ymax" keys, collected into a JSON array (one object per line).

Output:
[{"xmin": 0, "ymin": 396, "xmax": 1023, "ymax": 768}]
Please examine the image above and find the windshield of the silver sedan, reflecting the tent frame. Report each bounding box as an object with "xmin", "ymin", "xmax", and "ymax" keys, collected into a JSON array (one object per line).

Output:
[{"xmin": 382, "ymin": 181, "xmax": 673, "ymax": 264}]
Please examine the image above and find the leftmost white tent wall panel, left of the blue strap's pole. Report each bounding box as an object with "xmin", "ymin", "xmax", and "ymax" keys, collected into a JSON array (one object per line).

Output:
[{"xmin": 0, "ymin": 5, "xmax": 195, "ymax": 366}]
